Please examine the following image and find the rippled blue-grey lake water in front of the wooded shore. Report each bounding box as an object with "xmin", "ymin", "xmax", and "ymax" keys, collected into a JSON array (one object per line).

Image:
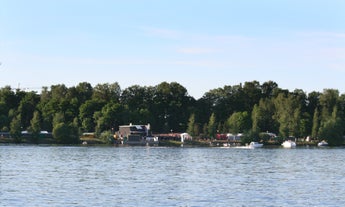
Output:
[{"xmin": 0, "ymin": 146, "xmax": 345, "ymax": 207}]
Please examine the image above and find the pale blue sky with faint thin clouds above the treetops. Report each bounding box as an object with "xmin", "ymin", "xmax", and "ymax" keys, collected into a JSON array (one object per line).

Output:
[{"xmin": 0, "ymin": 0, "xmax": 345, "ymax": 99}]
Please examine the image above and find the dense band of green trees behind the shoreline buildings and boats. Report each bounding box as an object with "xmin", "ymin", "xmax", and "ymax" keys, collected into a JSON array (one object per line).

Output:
[{"xmin": 0, "ymin": 81, "xmax": 345, "ymax": 145}]
